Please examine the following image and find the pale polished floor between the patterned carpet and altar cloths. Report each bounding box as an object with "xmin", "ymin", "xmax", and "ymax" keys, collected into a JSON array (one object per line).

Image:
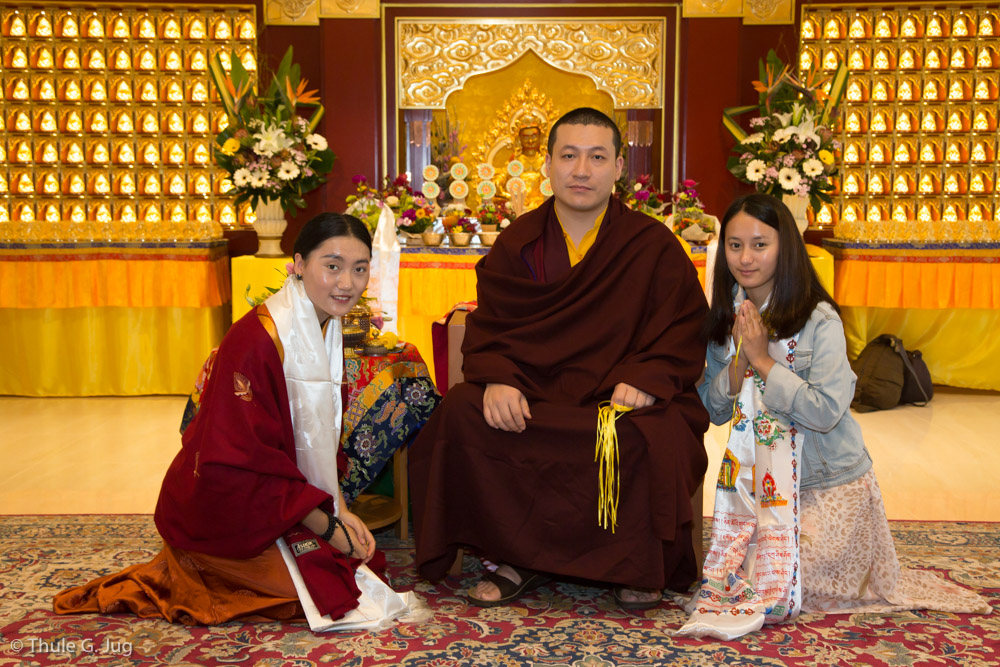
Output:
[{"xmin": 0, "ymin": 387, "xmax": 1000, "ymax": 521}]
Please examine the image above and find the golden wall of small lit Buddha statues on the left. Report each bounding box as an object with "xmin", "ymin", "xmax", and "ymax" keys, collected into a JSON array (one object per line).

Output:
[{"xmin": 0, "ymin": 4, "xmax": 257, "ymax": 241}]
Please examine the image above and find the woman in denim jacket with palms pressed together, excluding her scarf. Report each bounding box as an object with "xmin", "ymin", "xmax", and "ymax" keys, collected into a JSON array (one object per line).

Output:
[{"xmin": 699, "ymin": 194, "xmax": 989, "ymax": 613}]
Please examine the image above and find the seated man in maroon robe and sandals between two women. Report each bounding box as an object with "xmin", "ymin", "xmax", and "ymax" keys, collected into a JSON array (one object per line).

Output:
[{"xmin": 410, "ymin": 108, "xmax": 708, "ymax": 609}]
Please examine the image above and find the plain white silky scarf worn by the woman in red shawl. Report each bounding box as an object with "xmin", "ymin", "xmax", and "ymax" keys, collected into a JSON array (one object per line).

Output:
[{"xmin": 266, "ymin": 276, "xmax": 425, "ymax": 632}]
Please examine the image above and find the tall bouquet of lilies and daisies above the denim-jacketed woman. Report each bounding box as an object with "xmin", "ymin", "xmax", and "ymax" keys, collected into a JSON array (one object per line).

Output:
[{"xmin": 723, "ymin": 50, "xmax": 847, "ymax": 209}]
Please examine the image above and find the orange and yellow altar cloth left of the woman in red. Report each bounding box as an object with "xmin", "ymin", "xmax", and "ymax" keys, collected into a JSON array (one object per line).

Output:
[{"xmin": 0, "ymin": 241, "xmax": 230, "ymax": 396}]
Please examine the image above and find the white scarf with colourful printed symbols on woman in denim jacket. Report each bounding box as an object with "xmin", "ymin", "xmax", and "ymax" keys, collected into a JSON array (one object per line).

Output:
[{"xmin": 675, "ymin": 289, "xmax": 802, "ymax": 640}]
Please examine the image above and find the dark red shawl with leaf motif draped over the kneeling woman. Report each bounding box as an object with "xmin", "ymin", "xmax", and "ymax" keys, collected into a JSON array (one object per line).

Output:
[{"xmin": 156, "ymin": 308, "xmax": 330, "ymax": 558}]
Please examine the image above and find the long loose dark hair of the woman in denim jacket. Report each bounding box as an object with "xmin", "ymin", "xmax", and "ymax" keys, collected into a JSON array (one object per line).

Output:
[{"xmin": 705, "ymin": 194, "xmax": 840, "ymax": 345}]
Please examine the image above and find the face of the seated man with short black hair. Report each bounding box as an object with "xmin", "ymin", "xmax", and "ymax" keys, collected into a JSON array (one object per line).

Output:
[{"xmin": 545, "ymin": 125, "xmax": 624, "ymax": 216}]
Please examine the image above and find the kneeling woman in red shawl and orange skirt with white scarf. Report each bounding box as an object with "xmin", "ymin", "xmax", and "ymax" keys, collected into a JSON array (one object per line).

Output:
[{"xmin": 54, "ymin": 213, "xmax": 420, "ymax": 630}]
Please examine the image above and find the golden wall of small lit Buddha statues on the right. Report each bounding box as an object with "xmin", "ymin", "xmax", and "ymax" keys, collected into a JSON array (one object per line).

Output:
[{"xmin": 799, "ymin": 3, "xmax": 1000, "ymax": 242}]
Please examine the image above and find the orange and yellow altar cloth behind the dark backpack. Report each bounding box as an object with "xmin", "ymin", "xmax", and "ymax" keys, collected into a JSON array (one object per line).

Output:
[{"xmin": 823, "ymin": 239, "xmax": 1000, "ymax": 390}]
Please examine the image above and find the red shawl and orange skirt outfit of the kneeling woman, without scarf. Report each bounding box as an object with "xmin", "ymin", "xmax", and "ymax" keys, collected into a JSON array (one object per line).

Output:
[{"xmin": 54, "ymin": 306, "xmax": 364, "ymax": 624}]
